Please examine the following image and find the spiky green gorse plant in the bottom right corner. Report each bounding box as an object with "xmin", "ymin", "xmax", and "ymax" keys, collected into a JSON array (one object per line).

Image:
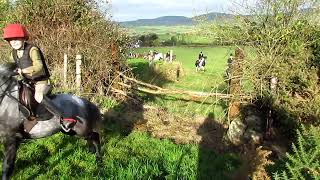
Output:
[{"xmin": 274, "ymin": 127, "xmax": 320, "ymax": 180}]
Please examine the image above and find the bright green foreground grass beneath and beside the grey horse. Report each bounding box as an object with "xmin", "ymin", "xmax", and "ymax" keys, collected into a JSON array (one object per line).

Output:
[{"xmin": 4, "ymin": 129, "xmax": 239, "ymax": 180}]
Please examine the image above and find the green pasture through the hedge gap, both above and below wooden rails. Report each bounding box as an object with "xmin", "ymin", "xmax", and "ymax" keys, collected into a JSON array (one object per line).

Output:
[{"xmin": 128, "ymin": 46, "xmax": 233, "ymax": 117}]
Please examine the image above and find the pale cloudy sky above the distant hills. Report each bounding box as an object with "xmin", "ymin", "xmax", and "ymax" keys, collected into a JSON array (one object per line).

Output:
[{"xmin": 109, "ymin": 0, "xmax": 233, "ymax": 21}]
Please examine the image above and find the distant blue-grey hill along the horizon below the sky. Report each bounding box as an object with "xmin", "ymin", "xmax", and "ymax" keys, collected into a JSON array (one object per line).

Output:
[{"xmin": 120, "ymin": 13, "xmax": 233, "ymax": 27}]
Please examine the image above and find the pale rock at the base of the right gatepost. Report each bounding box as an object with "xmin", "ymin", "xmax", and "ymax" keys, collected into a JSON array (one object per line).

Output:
[{"xmin": 227, "ymin": 119, "xmax": 247, "ymax": 145}]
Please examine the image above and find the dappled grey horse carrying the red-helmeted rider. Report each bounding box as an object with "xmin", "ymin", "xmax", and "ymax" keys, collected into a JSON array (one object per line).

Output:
[{"xmin": 0, "ymin": 64, "xmax": 101, "ymax": 179}]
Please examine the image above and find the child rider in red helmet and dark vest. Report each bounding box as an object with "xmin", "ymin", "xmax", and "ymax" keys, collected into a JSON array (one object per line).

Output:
[{"xmin": 3, "ymin": 24, "xmax": 71, "ymax": 129}]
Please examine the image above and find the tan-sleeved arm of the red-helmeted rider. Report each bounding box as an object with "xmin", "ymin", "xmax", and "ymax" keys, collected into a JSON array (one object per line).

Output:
[{"xmin": 22, "ymin": 47, "xmax": 43, "ymax": 76}]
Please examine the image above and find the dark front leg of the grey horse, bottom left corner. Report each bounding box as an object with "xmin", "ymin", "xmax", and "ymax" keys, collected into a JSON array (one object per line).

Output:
[{"xmin": 2, "ymin": 137, "xmax": 19, "ymax": 180}]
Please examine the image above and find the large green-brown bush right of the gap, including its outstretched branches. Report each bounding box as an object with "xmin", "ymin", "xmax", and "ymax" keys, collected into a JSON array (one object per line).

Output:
[{"xmin": 209, "ymin": 0, "xmax": 320, "ymax": 129}]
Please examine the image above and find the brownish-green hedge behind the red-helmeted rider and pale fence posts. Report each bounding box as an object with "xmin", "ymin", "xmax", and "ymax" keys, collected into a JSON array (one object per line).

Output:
[{"xmin": 0, "ymin": 0, "xmax": 128, "ymax": 98}]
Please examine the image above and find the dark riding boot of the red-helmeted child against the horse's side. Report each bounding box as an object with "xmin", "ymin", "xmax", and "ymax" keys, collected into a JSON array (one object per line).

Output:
[{"xmin": 41, "ymin": 96, "xmax": 75, "ymax": 132}]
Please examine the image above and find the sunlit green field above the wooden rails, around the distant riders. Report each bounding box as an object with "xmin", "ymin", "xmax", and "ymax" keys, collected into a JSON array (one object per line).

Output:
[{"xmin": 128, "ymin": 47, "xmax": 234, "ymax": 92}]
